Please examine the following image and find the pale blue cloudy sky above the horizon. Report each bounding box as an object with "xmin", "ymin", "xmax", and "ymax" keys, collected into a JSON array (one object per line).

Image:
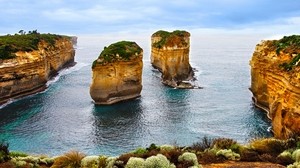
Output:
[{"xmin": 0, "ymin": 0, "xmax": 300, "ymax": 35}]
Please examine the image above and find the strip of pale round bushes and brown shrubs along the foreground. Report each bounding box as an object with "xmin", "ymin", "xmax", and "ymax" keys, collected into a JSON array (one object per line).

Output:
[{"xmin": 0, "ymin": 137, "xmax": 300, "ymax": 168}]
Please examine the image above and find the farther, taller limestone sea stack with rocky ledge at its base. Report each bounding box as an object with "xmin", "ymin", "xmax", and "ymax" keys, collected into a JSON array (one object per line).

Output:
[{"xmin": 151, "ymin": 30, "xmax": 194, "ymax": 88}]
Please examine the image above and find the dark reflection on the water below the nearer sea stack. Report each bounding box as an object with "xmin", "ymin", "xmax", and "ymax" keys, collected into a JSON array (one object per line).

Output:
[{"xmin": 92, "ymin": 98, "xmax": 145, "ymax": 153}]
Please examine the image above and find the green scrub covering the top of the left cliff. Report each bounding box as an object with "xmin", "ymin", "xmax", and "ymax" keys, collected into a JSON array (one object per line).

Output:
[{"xmin": 0, "ymin": 30, "xmax": 66, "ymax": 59}]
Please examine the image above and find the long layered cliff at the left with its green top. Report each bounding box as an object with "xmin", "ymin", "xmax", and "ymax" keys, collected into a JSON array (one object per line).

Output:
[{"xmin": 0, "ymin": 33, "xmax": 75, "ymax": 104}]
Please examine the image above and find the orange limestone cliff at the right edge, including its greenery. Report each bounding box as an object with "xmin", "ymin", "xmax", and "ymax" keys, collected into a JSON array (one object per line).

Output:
[{"xmin": 250, "ymin": 35, "xmax": 300, "ymax": 139}]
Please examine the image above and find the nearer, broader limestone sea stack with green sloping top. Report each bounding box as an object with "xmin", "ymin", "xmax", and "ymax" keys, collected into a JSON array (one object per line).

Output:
[{"xmin": 90, "ymin": 41, "xmax": 143, "ymax": 105}]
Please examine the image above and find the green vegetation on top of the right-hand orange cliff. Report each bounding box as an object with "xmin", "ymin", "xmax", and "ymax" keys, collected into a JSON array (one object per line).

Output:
[{"xmin": 274, "ymin": 35, "xmax": 300, "ymax": 71}]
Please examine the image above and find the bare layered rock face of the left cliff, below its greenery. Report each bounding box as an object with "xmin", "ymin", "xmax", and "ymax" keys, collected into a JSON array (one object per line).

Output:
[{"xmin": 0, "ymin": 37, "xmax": 75, "ymax": 104}]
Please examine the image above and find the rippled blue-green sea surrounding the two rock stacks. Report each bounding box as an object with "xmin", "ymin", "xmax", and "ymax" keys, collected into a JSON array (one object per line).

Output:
[{"xmin": 0, "ymin": 34, "xmax": 272, "ymax": 156}]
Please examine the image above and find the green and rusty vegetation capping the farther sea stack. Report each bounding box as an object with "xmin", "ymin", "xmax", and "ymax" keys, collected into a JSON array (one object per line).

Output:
[{"xmin": 152, "ymin": 30, "xmax": 190, "ymax": 48}]
